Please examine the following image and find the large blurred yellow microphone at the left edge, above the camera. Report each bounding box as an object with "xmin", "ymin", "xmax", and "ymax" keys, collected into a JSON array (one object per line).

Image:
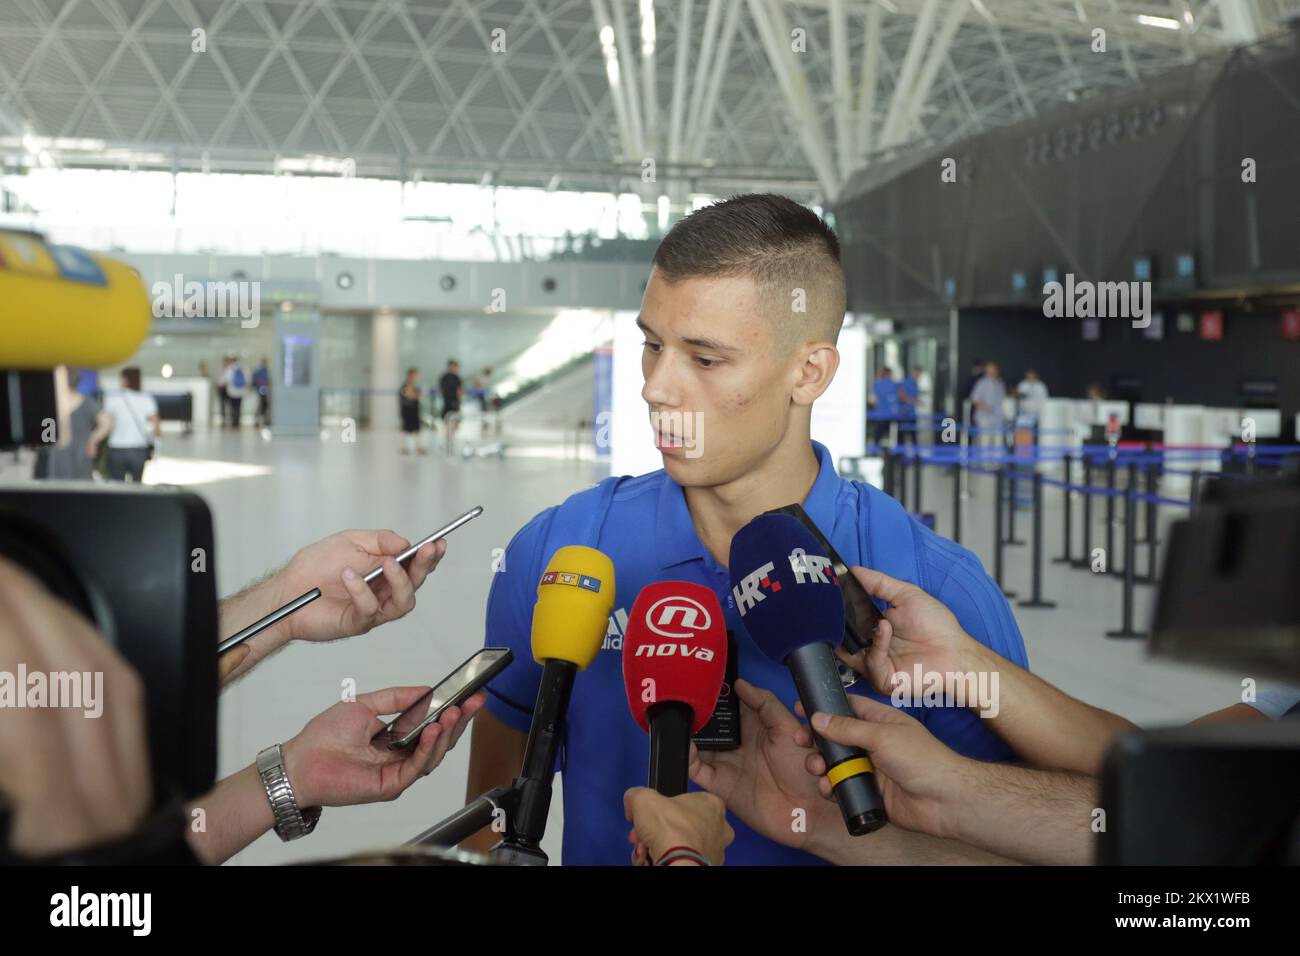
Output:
[{"xmin": 0, "ymin": 229, "xmax": 153, "ymax": 369}]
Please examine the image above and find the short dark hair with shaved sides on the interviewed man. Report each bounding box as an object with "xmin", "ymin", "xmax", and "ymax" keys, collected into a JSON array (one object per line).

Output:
[{"xmin": 654, "ymin": 193, "xmax": 845, "ymax": 342}]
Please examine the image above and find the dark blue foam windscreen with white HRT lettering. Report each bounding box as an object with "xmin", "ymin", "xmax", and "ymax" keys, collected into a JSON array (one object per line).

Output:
[{"xmin": 727, "ymin": 515, "xmax": 844, "ymax": 662}]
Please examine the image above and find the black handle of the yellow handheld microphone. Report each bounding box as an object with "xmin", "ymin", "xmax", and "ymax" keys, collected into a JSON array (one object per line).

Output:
[{"xmin": 507, "ymin": 659, "xmax": 577, "ymax": 847}]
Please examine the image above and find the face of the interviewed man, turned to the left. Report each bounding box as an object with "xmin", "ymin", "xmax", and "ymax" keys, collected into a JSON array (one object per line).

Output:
[{"xmin": 637, "ymin": 271, "xmax": 800, "ymax": 486}]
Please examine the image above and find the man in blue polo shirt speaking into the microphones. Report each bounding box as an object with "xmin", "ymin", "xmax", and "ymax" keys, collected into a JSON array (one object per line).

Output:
[{"xmin": 467, "ymin": 195, "xmax": 1027, "ymax": 865}]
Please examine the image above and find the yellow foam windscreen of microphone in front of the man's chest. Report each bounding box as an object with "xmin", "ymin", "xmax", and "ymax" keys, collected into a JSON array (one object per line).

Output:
[{"xmin": 533, "ymin": 545, "xmax": 614, "ymax": 670}]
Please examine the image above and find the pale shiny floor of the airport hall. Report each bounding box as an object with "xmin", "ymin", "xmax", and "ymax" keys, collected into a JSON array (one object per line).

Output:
[{"xmin": 0, "ymin": 429, "xmax": 1243, "ymax": 864}]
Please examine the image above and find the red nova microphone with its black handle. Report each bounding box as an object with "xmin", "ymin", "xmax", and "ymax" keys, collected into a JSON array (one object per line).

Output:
[{"xmin": 623, "ymin": 581, "xmax": 727, "ymax": 796}]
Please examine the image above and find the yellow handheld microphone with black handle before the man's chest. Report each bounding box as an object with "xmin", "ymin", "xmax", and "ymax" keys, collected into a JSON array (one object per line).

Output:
[{"xmin": 493, "ymin": 545, "xmax": 614, "ymax": 864}]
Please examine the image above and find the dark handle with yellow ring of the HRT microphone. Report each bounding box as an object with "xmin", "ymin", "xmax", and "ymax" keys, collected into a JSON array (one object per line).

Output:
[{"xmin": 785, "ymin": 641, "xmax": 889, "ymax": 836}]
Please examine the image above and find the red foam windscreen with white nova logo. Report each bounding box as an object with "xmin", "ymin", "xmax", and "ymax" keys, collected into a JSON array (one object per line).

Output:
[{"xmin": 623, "ymin": 581, "xmax": 727, "ymax": 734}]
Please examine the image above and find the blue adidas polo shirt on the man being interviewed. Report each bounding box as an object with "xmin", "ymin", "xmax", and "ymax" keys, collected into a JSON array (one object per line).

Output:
[{"xmin": 486, "ymin": 442, "xmax": 1028, "ymax": 865}]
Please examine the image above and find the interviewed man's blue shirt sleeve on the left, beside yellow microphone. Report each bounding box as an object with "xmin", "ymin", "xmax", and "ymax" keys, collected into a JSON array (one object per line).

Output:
[{"xmin": 484, "ymin": 509, "xmax": 555, "ymax": 734}]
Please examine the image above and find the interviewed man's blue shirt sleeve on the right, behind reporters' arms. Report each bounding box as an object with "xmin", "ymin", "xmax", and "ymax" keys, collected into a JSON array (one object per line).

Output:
[{"xmin": 913, "ymin": 532, "xmax": 1030, "ymax": 760}]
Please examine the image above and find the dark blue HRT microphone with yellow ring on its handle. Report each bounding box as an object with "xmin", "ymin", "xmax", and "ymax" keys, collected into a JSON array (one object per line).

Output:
[{"xmin": 728, "ymin": 515, "xmax": 888, "ymax": 836}]
